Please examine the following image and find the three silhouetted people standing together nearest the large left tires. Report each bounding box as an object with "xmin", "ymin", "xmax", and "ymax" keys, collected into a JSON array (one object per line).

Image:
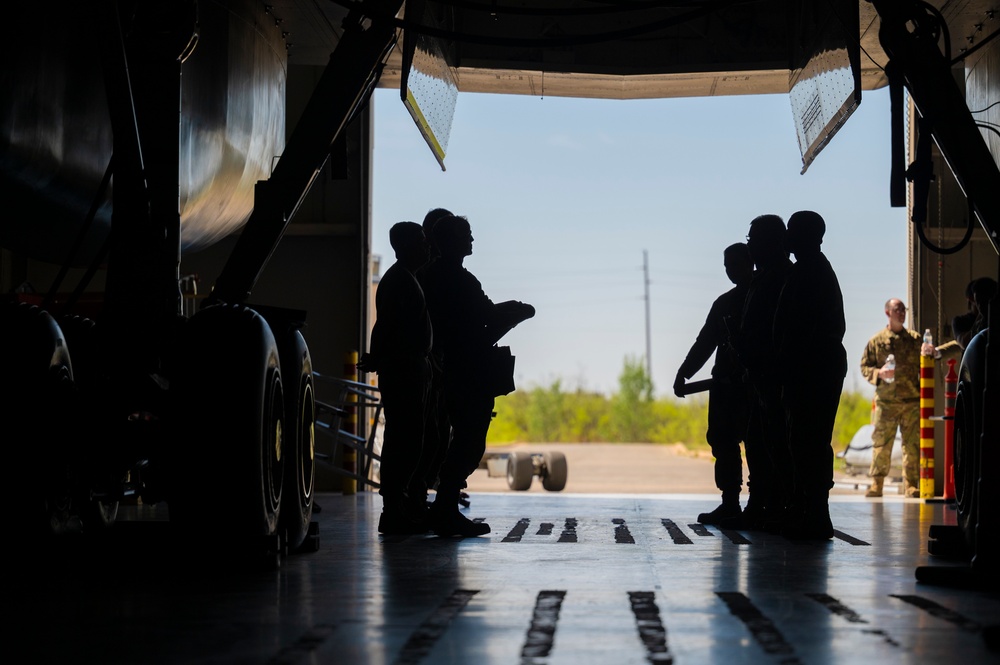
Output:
[{"xmin": 358, "ymin": 208, "xmax": 535, "ymax": 537}]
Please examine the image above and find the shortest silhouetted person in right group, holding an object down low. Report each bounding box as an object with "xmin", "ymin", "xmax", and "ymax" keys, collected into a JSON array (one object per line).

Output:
[{"xmin": 674, "ymin": 243, "xmax": 753, "ymax": 527}]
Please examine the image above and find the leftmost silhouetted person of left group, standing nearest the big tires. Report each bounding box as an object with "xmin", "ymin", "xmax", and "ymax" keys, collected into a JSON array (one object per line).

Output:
[{"xmin": 358, "ymin": 222, "xmax": 433, "ymax": 534}]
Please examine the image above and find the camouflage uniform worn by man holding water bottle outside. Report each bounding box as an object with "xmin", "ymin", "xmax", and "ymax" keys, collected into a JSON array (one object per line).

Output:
[{"xmin": 861, "ymin": 327, "xmax": 923, "ymax": 487}]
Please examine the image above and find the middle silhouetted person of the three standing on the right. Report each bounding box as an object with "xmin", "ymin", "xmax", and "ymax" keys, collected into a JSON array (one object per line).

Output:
[{"xmin": 735, "ymin": 215, "xmax": 792, "ymax": 531}]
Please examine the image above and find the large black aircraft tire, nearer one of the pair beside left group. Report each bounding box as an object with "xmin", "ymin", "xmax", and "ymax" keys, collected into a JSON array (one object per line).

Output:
[{"xmin": 167, "ymin": 305, "xmax": 284, "ymax": 557}]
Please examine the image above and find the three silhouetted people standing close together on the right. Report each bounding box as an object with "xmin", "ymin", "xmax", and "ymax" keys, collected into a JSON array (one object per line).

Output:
[{"xmin": 674, "ymin": 211, "xmax": 847, "ymax": 540}]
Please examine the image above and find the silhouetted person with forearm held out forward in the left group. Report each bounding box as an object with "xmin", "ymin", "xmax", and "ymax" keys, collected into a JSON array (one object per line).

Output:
[{"xmin": 424, "ymin": 216, "xmax": 535, "ymax": 536}]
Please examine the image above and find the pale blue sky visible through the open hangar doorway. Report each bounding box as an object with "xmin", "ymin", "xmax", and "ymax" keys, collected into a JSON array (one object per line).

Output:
[{"xmin": 372, "ymin": 89, "xmax": 907, "ymax": 396}]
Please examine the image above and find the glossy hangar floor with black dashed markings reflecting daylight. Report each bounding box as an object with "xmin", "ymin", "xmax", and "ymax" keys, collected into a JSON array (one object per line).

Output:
[{"xmin": 4, "ymin": 492, "xmax": 1000, "ymax": 665}]
